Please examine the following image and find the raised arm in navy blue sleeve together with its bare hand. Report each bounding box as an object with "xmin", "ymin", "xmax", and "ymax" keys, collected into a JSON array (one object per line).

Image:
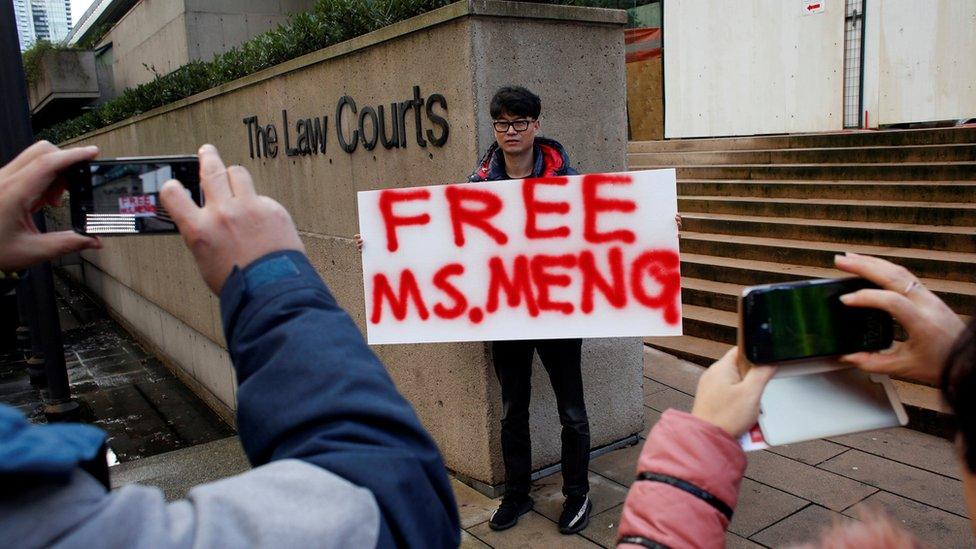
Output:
[{"xmin": 160, "ymin": 145, "xmax": 460, "ymax": 547}]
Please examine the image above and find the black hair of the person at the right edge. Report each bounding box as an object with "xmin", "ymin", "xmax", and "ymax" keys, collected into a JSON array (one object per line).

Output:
[{"xmin": 942, "ymin": 320, "xmax": 976, "ymax": 473}]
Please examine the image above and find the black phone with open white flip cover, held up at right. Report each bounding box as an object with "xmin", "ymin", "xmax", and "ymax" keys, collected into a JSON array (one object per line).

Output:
[{"xmin": 739, "ymin": 260, "xmax": 908, "ymax": 445}]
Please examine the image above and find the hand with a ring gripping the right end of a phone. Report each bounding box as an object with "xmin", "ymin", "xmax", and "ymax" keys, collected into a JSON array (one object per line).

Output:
[{"xmin": 834, "ymin": 253, "xmax": 965, "ymax": 383}]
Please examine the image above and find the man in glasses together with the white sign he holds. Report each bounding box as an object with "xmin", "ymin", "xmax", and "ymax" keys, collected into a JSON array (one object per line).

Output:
[{"xmin": 359, "ymin": 88, "xmax": 681, "ymax": 534}]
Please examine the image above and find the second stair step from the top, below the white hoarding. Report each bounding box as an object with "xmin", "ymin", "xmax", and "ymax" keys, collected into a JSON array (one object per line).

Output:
[{"xmin": 627, "ymin": 143, "xmax": 976, "ymax": 165}]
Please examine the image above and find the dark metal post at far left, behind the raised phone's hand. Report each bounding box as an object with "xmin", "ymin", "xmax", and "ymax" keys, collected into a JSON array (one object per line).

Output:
[{"xmin": 0, "ymin": 2, "xmax": 79, "ymax": 421}]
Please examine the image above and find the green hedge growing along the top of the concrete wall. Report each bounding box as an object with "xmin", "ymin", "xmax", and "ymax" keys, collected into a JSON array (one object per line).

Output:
[{"xmin": 37, "ymin": 0, "xmax": 646, "ymax": 143}]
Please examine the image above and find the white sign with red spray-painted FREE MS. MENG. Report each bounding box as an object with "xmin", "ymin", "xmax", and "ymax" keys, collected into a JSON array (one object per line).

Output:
[{"xmin": 358, "ymin": 169, "xmax": 681, "ymax": 344}]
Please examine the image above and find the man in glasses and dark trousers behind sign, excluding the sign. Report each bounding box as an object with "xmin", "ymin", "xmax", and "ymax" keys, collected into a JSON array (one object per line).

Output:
[{"xmin": 469, "ymin": 87, "xmax": 593, "ymax": 534}]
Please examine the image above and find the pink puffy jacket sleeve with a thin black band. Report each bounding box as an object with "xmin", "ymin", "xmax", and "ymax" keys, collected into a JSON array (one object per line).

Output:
[{"xmin": 618, "ymin": 410, "xmax": 746, "ymax": 549}]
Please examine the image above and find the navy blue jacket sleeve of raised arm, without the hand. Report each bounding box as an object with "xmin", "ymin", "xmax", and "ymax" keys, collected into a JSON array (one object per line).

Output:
[{"xmin": 220, "ymin": 251, "xmax": 460, "ymax": 547}]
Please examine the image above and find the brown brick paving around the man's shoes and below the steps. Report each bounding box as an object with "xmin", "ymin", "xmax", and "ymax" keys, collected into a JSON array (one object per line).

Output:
[{"xmin": 452, "ymin": 349, "xmax": 974, "ymax": 548}]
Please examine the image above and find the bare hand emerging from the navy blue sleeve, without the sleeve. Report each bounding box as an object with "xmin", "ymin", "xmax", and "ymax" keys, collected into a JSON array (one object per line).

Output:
[{"xmin": 160, "ymin": 145, "xmax": 305, "ymax": 294}]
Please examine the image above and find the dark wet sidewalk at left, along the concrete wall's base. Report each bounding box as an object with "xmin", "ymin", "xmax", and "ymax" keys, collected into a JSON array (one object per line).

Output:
[{"xmin": 0, "ymin": 276, "xmax": 234, "ymax": 463}]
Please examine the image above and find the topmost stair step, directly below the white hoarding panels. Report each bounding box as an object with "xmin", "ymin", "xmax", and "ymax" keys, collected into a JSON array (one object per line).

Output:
[{"xmin": 627, "ymin": 126, "xmax": 976, "ymax": 152}]
